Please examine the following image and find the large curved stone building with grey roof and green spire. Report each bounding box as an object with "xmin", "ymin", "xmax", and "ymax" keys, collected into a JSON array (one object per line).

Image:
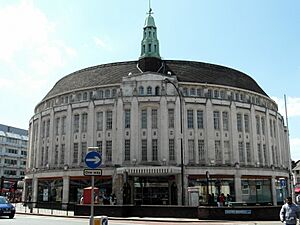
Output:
[{"xmin": 25, "ymin": 10, "xmax": 291, "ymax": 205}]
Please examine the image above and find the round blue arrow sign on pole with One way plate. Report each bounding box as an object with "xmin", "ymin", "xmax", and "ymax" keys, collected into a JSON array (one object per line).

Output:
[{"xmin": 83, "ymin": 147, "xmax": 102, "ymax": 225}]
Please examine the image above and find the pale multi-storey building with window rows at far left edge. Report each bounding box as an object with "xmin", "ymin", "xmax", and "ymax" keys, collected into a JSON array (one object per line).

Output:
[{"xmin": 0, "ymin": 124, "xmax": 28, "ymax": 181}]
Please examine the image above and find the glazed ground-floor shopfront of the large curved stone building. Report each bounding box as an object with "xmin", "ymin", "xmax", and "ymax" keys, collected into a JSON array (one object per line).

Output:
[{"xmin": 23, "ymin": 167, "xmax": 290, "ymax": 206}]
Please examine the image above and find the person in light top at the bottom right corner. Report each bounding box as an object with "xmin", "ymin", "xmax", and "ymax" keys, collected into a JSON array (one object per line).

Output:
[{"xmin": 279, "ymin": 197, "xmax": 300, "ymax": 225}]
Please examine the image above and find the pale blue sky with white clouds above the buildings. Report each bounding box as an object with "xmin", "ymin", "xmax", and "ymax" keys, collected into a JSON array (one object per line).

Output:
[{"xmin": 0, "ymin": 0, "xmax": 300, "ymax": 161}]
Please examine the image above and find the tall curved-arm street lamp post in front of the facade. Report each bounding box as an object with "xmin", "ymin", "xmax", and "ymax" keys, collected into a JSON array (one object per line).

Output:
[{"xmin": 164, "ymin": 78, "xmax": 185, "ymax": 205}]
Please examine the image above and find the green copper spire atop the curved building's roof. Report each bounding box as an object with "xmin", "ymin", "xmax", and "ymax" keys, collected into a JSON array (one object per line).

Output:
[{"xmin": 140, "ymin": 5, "xmax": 160, "ymax": 59}]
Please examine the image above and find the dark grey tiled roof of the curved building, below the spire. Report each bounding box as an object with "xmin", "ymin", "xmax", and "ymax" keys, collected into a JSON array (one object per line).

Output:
[{"xmin": 44, "ymin": 60, "xmax": 267, "ymax": 99}]
